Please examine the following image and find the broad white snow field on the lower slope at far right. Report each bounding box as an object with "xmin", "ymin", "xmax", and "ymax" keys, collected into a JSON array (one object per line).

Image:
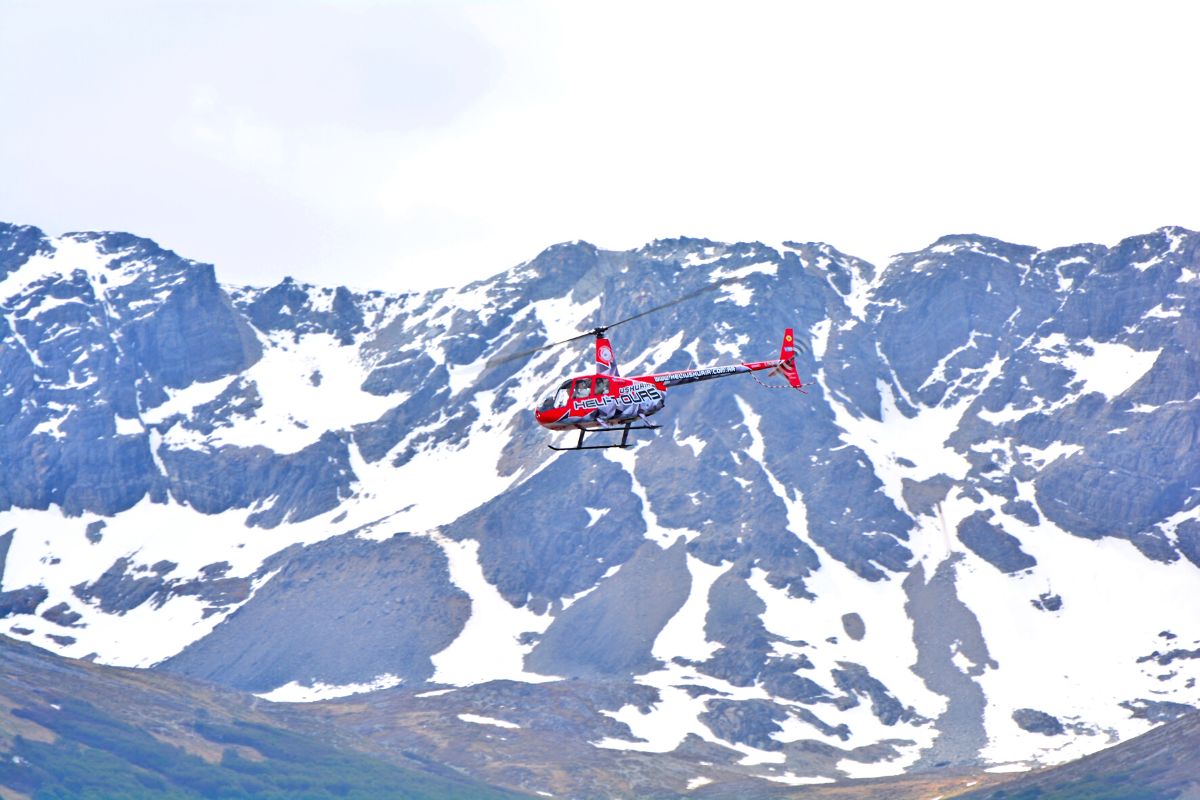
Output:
[{"xmin": 946, "ymin": 491, "xmax": 1200, "ymax": 766}]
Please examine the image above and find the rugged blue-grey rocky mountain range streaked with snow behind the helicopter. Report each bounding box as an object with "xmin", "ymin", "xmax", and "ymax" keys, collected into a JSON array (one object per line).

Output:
[{"xmin": 0, "ymin": 219, "xmax": 1200, "ymax": 794}]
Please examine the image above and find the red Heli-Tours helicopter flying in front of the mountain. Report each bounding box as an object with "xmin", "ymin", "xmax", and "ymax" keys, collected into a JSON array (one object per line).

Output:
[{"xmin": 496, "ymin": 279, "xmax": 808, "ymax": 451}]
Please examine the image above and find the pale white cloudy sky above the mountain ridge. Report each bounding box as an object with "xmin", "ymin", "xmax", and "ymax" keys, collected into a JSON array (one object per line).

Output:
[{"xmin": 0, "ymin": 0, "xmax": 1200, "ymax": 290}]
